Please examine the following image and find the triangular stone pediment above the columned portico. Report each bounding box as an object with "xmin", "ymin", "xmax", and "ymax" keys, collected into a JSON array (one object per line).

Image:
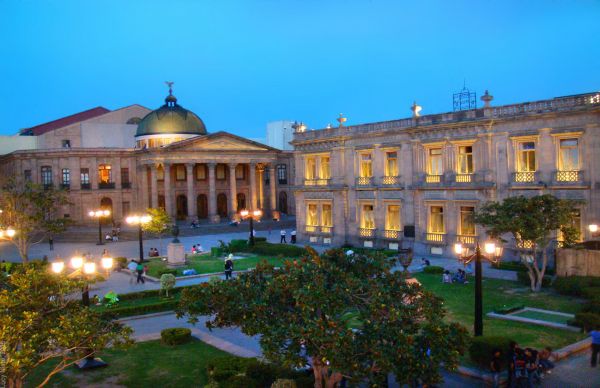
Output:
[{"xmin": 165, "ymin": 132, "xmax": 274, "ymax": 151}]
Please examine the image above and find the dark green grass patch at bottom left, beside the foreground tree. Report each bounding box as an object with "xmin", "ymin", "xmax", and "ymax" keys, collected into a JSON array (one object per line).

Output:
[{"xmin": 25, "ymin": 340, "xmax": 234, "ymax": 388}]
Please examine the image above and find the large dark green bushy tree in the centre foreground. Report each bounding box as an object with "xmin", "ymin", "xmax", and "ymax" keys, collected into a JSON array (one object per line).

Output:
[{"xmin": 177, "ymin": 248, "xmax": 466, "ymax": 388}]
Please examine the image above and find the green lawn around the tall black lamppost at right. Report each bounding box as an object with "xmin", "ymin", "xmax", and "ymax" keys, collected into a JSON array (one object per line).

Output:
[{"xmin": 415, "ymin": 273, "xmax": 585, "ymax": 349}]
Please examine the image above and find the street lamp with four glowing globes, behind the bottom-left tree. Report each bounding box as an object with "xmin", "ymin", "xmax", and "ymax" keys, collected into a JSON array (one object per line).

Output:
[{"xmin": 51, "ymin": 254, "xmax": 113, "ymax": 369}]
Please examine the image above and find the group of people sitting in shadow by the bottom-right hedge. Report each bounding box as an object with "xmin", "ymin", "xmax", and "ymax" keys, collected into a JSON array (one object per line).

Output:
[{"xmin": 490, "ymin": 341, "xmax": 554, "ymax": 387}]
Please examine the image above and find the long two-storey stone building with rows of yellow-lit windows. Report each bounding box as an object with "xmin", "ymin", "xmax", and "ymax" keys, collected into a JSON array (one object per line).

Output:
[{"xmin": 292, "ymin": 91, "xmax": 600, "ymax": 254}]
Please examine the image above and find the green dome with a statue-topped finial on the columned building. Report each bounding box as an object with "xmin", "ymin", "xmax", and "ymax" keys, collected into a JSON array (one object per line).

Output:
[{"xmin": 135, "ymin": 94, "xmax": 206, "ymax": 137}]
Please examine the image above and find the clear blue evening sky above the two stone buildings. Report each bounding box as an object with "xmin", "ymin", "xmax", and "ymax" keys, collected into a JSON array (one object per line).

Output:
[{"xmin": 0, "ymin": 0, "xmax": 600, "ymax": 137}]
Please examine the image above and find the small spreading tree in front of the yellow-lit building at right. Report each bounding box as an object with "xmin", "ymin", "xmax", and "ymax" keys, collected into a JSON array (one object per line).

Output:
[{"xmin": 474, "ymin": 194, "xmax": 580, "ymax": 292}]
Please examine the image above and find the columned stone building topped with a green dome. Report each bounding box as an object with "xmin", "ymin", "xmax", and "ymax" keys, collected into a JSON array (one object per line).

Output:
[{"xmin": 0, "ymin": 91, "xmax": 295, "ymax": 223}]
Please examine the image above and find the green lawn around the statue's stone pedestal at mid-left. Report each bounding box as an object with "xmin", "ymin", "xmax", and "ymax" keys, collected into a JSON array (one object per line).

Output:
[{"xmin": 148, "ymin": 255, "xmax": 285, "ymax": 277}]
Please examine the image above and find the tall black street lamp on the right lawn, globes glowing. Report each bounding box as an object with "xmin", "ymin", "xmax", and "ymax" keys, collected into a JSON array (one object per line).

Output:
[{"xmin": 454, "ymin": 241, "xmax": 502, "ymax": 337}]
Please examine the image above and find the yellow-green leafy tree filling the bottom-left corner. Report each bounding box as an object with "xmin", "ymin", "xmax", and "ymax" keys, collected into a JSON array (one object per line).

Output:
[{"xmin": 0, "ymin": 265, "xmax": 131, "ymax": 388}]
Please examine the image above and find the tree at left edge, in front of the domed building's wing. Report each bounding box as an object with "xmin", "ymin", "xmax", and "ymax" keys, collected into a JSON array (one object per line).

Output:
[{"xmin": 0, "ymin": 179, "xmax": 69, "ymax": 264}]
